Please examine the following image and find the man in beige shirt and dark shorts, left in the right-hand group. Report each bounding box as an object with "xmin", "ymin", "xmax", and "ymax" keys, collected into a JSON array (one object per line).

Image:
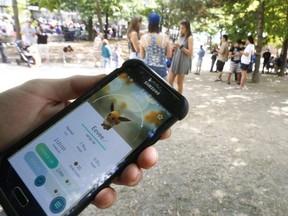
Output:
[{"xmin": 215, "ymin": 35, "xmax": 229, "ymax": 82}]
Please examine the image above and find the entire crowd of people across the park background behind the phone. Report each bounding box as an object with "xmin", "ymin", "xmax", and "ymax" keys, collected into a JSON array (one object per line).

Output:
[{"xmin": 0, "ymin": 13, "xmax": 281, "ymax": 93}]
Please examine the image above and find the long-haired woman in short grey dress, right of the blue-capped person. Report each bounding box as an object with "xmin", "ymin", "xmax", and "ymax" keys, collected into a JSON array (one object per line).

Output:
[{"xmin": 168, "ymin": 19, "xmax": 193, "ymax": 94}]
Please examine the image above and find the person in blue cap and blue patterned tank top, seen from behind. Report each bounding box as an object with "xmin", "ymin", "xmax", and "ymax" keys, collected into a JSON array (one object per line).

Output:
[{"xmin": 140, "ymin": 13, "xmax": 172, "ymax": 80}]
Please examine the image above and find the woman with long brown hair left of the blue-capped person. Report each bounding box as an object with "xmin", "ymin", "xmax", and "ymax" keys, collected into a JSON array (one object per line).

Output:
[{"xmin": 127, "ymin": 15, "xmax": 142, "ymax": 59}]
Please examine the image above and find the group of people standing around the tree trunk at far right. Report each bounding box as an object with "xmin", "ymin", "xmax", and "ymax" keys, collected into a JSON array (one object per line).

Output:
[{"xmin": 210, "ymin": 35, "xmax": 288, "ymax": 89}]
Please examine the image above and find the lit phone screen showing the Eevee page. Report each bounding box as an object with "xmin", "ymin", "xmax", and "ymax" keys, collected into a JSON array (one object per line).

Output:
[{"xmin": 9, "ymin": 73, "xmax": 171, "ymax": 215}]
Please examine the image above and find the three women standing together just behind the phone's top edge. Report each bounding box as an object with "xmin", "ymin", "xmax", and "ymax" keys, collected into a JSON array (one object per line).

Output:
[{"xmin": 127, "ymin": 13, "xmax": 193, "ymax": 94}]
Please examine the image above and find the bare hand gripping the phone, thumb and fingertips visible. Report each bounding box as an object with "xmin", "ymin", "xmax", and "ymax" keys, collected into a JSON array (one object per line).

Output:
[{"xmin": 0, "ymin": 75, "xmax": 171, "ymax": 208}]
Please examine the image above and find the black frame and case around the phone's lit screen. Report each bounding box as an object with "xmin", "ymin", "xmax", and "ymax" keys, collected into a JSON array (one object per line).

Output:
[{"xmin": 0, "ymin": 60, "xmax": 189, "ymax": 215}]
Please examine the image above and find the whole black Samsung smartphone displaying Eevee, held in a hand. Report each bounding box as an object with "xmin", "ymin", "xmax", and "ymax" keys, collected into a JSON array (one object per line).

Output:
[{"xmin": 0, "ymin": 60, "xmax": 188, "ymax": 216}]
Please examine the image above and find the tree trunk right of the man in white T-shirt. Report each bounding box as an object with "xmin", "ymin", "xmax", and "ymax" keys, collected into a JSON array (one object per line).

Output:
[{"xmin": 252, "ymin": 0, "xmax": 265, "ymax": 83}]
